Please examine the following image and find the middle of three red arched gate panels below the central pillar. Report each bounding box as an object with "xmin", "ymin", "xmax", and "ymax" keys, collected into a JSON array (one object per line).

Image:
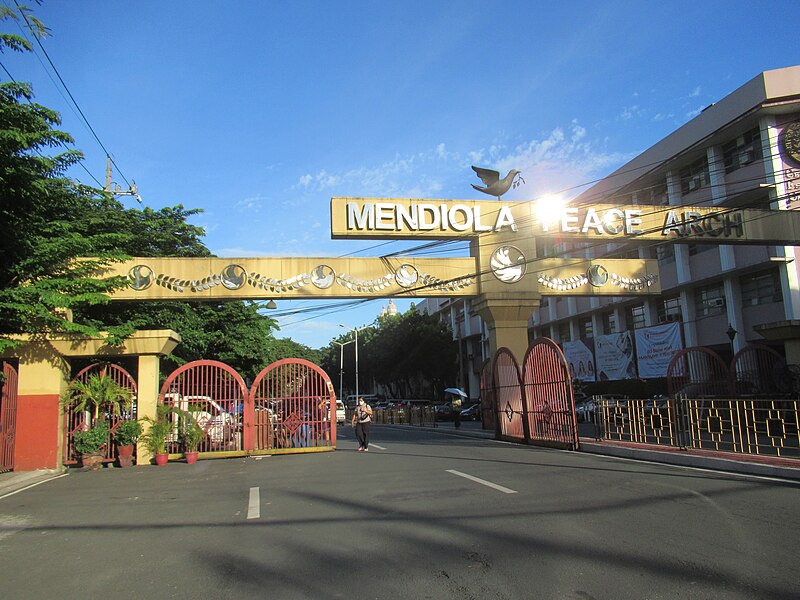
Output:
[{"xmin": 492, "ymin": 348, "xmax": 529, "ymax": 440}]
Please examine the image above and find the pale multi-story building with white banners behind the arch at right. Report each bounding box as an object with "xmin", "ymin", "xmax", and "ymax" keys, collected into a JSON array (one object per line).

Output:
[{"xmin": 419, "ymin": 66, "xmax": 800, "ymax": 396}]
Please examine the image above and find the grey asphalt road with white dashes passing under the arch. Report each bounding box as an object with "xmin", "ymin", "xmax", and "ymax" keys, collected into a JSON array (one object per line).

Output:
[{"xmin": 0, "ymin": 427, "xmax": 800, "ymax": 600}]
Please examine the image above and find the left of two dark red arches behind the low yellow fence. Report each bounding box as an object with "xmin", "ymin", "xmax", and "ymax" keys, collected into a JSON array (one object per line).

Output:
[{"xmin": 667, "ymin": 346, "xmax": 730, "ymax": 398}]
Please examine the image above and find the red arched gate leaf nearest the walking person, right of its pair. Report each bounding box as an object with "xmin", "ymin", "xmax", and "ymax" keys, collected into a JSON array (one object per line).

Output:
[{"xmin": 250, "ymin": 358, "xmax": 336, "ymax": 450}]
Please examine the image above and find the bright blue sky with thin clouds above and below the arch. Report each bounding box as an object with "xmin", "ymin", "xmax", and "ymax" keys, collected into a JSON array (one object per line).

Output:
[{"xmin": 0, "ymin": 0, "xmax": 800, "ymax": 347}]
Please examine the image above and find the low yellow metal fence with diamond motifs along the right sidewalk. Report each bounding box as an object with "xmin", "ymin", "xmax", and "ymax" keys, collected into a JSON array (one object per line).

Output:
[{"xmin": 588, "ymin": 397, "xmax": 800, "ymax": 459}]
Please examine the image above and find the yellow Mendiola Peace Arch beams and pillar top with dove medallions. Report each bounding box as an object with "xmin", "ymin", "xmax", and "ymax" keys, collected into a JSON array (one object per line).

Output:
[{"xmin": 110, "ymin": 197, "xmax": 800, "ymax": 359}]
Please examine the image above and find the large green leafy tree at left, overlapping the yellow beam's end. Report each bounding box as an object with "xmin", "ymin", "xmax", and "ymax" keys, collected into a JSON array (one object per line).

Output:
[{"xmin": 0, "ymin": 5, "xmax": 319, "ymax": 368}]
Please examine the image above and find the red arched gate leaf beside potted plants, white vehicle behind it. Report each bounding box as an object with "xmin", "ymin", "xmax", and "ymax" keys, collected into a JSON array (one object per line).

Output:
[{"xmin": 158, "ymin": 360, "xmax": 252, "ymax": 454}]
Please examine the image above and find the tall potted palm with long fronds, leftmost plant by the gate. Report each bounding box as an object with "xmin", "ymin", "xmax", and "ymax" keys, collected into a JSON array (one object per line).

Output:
[{"xmin": 61, "ymin": 373, "xmax": 133, "ymax": 470}]
